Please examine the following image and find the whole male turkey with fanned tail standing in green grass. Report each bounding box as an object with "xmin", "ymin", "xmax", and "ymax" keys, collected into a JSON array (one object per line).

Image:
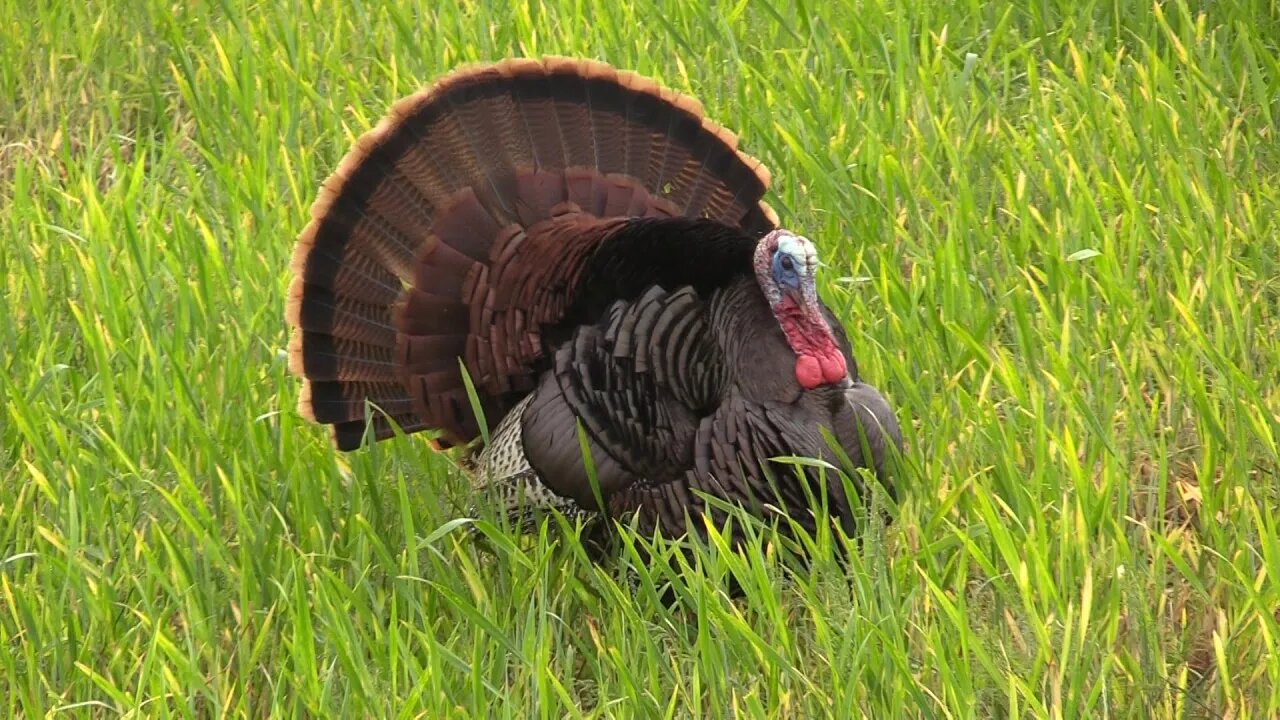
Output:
[{"xmin": 287, "ymin": 58, "xmax": 901, "ymax": 537}]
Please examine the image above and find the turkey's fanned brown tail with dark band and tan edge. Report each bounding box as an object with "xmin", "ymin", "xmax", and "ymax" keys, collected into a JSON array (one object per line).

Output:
[{"xmin": 285, "ymin": 58, "xmax": 776, "ymax": 450}]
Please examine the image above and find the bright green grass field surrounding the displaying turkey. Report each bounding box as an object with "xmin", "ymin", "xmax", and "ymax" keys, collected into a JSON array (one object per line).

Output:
[{"xmin": 0, "ymin": 0, "xmax": 1280, "ymax": 719}]
